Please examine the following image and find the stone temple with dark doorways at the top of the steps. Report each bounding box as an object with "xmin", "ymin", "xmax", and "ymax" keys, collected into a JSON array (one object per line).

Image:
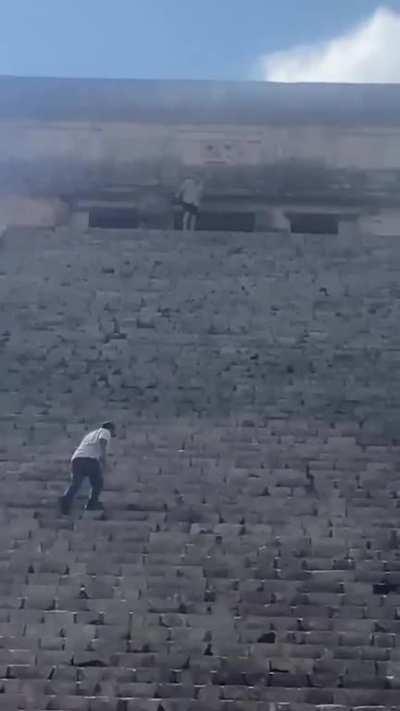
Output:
[{"xmin": 0, "ymin": 77, "xmax": 400, "ymax": 236}]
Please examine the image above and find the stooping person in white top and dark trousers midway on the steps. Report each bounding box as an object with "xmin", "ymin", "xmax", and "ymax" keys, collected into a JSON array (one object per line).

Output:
[{"xmin": 59, "ymin": 422, "xmax": 115, "ymax": 514}]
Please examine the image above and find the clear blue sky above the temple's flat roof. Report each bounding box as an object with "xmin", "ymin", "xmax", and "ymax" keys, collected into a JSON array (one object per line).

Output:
[{"xmin": 0, "ymin": 0, "xmax": 400, "ymax": 81}]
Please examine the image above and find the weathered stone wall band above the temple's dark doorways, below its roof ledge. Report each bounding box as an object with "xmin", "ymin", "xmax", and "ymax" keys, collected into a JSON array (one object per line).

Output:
[{"xmin": 0, "ymin": 120, "xmax": 400, "ymax": 199}]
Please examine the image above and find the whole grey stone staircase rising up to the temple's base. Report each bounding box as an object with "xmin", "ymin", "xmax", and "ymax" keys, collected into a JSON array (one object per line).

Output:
[{"xmin": 0, "ymin": 231, "xmax": 400, "ymax": 711}]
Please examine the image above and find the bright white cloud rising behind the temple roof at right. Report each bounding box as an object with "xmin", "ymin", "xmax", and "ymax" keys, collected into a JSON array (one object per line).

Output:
[{"xmin": 261, "ymin": 7, "xmax": 400, "ymax": 83}]
